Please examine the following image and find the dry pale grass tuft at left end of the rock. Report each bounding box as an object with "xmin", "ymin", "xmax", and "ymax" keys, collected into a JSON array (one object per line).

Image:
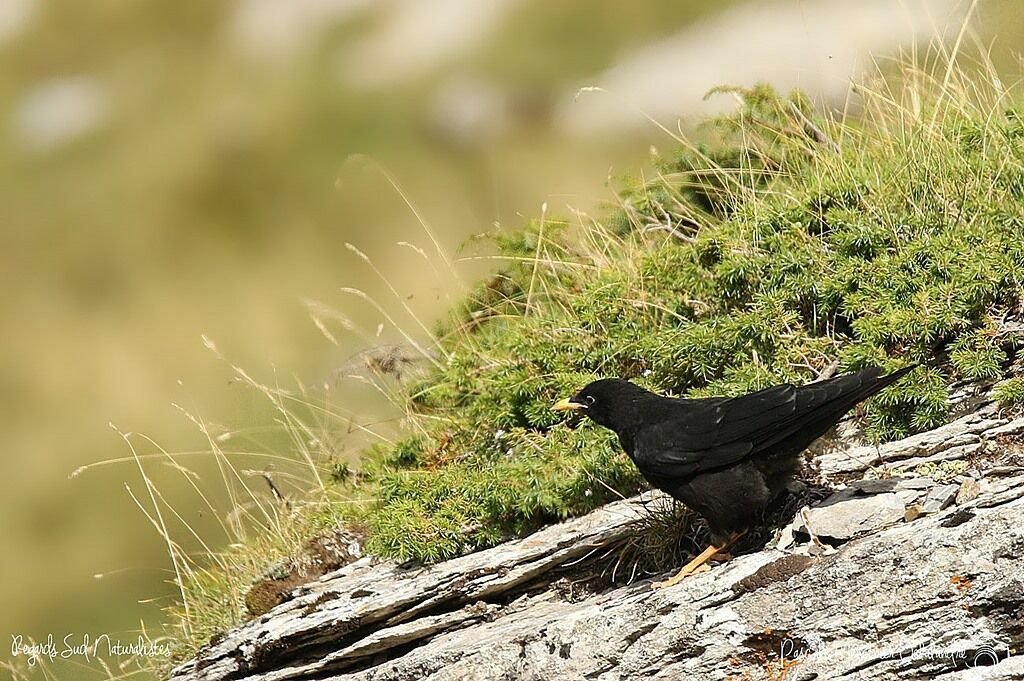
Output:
[{"xmin": 116, "ymin": 352, "xmax": 387, "ymax": 678}]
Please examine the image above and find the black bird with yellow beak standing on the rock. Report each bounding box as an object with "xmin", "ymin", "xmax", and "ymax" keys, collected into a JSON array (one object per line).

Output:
[{"xmin": 554, "ymin": 365, "xmax": 916, "ymax": 588}]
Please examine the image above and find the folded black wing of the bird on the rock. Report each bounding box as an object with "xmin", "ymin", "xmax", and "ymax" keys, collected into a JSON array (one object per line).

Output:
[{"xmin": 633, "ymin": 367, "xmax": 913, "ymax": 477}]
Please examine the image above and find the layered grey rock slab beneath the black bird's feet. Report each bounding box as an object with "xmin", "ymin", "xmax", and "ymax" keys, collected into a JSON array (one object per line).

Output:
[{"xmin": 172, "ymin": 405, "xmax": 1024, "ymax": 681}]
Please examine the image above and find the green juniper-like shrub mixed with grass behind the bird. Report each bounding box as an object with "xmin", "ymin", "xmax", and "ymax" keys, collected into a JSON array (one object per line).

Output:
[{"xmin": 161, "ymin": 51, "xmax": 1024, "ymax": 663}]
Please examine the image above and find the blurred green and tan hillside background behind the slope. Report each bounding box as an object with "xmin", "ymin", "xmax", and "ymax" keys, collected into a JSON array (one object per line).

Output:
[{"xmin": 0, "ymin": 0, "xmax": 1024, "ymax": 676}]
